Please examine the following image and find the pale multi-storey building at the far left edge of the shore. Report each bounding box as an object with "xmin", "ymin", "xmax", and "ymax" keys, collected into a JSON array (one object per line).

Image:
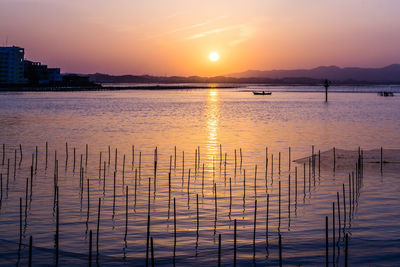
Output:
[{"xmin": 0, "ymin": 46, "xmax": 25, "ymax": 84}]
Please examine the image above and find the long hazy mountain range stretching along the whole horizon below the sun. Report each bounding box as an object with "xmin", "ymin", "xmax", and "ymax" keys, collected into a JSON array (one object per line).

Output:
[{"xmin": 87, "ymin": 64, "xmax": 400, "ymax": 85}]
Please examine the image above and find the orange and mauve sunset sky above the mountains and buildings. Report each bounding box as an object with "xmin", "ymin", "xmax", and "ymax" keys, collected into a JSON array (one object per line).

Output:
[{"xmin": 0, "ymin": 0, "xmax": 400, "ymax": 76}]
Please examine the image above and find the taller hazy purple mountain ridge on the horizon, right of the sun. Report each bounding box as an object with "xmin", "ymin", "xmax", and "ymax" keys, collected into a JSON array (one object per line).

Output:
[{"xmin": 227, "ymin": 64, "xmax": 400, "ymax": 82}]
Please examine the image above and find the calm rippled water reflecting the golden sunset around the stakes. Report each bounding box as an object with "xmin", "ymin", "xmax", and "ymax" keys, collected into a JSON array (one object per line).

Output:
[{"xmin": 0, "ymin": 86, "xmax": 400, "ymax": 266}]
